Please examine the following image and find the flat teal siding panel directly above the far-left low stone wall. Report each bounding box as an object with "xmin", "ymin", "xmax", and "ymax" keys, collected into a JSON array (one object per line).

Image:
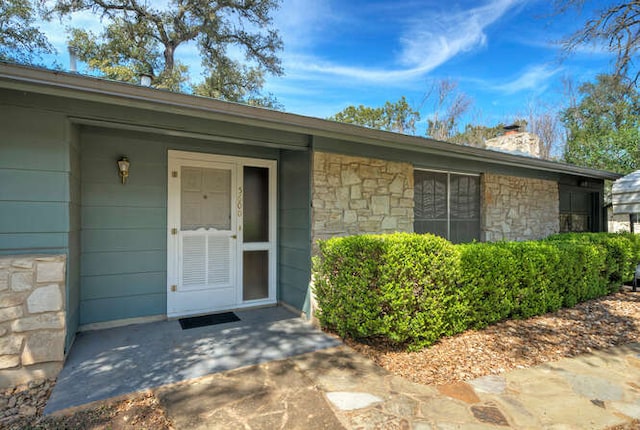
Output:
[{"xmin": 0, "ymin": 104, "xmax": 70, "ymax": 255}]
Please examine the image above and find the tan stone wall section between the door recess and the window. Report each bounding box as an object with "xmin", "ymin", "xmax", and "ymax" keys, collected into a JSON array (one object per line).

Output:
[{"xmin": 312, "ymin": 152, "xmax": 413, "ymax": 247}]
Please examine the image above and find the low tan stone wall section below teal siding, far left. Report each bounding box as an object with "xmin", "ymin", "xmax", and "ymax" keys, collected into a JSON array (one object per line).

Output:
[{"xmin": 0, "ymin": 255, "xmax": 66, "ymax": 389}]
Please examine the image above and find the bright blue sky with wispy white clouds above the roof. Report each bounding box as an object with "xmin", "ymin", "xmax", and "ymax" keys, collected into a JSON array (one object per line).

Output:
[{"xmin": 36, "ymin": 0, "xmax": 611, "ymax": 134}]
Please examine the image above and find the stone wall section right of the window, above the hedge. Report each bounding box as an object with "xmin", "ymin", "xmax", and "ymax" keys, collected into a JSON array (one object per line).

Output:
[{"xmin": 482, "ymin": 174, "xmax": 560, "ymax": 242}]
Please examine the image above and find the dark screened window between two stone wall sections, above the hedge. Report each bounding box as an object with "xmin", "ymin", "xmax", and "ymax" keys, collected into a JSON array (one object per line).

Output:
[{"xmin": 413, "ymin": 170, "xmax": 480, "ymax": 243}]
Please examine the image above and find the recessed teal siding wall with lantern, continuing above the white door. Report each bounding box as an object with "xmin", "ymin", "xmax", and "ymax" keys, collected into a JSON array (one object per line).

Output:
[{"xmin": 80, "ymin": 127, "xmax": 279, "ymax": 325}]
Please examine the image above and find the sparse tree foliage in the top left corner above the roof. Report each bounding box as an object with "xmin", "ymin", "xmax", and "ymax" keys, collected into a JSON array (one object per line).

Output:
[{"xmin": 0, "ymin": 0, "xmax": 54, "ymax": 63}]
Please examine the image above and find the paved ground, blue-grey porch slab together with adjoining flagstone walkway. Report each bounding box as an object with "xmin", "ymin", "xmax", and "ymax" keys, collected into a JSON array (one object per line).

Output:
[{"xmin": 45, "ymin": 308, "xmax": 640, "ymax": 430}]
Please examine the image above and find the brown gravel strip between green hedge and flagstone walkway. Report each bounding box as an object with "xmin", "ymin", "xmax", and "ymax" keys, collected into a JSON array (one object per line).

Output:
[{"xmin": 348, "ymin": 291, "xmax": 640, "ymax": 385}]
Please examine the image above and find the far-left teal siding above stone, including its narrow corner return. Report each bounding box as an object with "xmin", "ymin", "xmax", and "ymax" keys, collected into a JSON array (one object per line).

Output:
[{"xmin": 0, "ymin": 104, "xmax": 80, "ymax": 351}]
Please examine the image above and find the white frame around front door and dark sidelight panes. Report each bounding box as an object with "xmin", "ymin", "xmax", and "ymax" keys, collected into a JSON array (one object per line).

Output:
[{"xmin": 166, "ymin": 150, "xmax": 278, "ymax": 318}]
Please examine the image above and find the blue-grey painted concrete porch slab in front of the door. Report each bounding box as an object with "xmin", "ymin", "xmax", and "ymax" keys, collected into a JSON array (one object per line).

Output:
[{"xmin": 45, "ymin": 307, "xmax": 340, "ymax": 414}]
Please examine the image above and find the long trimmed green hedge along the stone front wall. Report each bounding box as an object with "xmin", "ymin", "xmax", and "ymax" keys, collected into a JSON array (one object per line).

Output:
[{"xmin": 314, "ymin": 233, "xmax": 640, "ymax": 349}]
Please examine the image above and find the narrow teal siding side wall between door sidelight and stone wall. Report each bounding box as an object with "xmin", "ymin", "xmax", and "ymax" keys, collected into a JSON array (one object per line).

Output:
[{"xmin": 278, "ymin": 151, "xmax": 311, "ymax": 314}]
